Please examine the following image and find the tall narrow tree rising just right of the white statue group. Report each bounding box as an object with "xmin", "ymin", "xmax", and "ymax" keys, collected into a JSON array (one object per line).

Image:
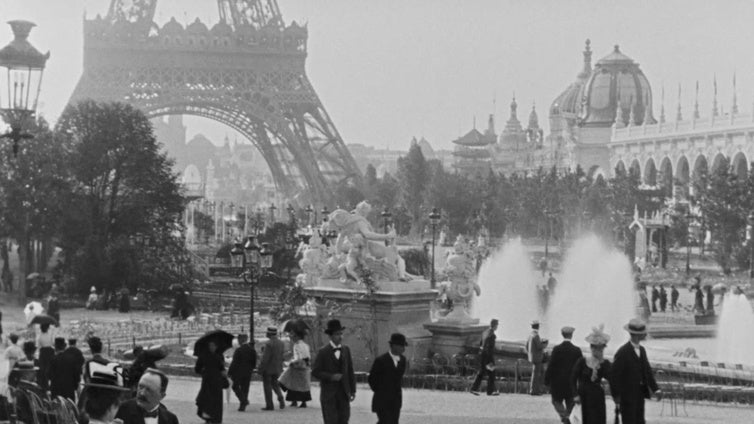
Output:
[{"xmin": 398, "ymin": 143, "xmax": 431, "ymax": 238}]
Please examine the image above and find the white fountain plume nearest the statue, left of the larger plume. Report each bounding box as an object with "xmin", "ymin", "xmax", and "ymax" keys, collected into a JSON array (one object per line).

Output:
[{"xmin": 472, "ymin": 238, "xmax": 539, "ymax": 340}]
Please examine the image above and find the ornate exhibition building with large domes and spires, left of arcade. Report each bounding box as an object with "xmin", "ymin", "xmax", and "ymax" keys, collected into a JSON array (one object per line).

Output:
[{"xmin": 494, "ymin": 40, "xmax": 657, "ymax": 173}]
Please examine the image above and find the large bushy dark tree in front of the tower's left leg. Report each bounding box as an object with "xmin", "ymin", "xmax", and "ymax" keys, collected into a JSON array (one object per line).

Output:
[{"xmin": 57, "ymin": 101, "xmax": 185, "ymax": 289}]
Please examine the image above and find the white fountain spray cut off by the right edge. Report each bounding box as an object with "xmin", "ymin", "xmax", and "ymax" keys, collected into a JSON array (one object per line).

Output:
[{"xmin": 716, "ymin": 293, "xmax": 754, "ymax": 364}]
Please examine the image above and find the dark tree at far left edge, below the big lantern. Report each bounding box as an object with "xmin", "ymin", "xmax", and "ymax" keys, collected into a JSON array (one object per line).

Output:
[{"xmin": 0, "ymin": 119, "xmax": 70, "ymax": 302}]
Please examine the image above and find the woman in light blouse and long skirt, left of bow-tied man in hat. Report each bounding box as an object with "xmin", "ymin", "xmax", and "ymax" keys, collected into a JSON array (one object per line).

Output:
[{"xmin": 279, "ymin": 329, "xmax": 312, "ymax": 408}]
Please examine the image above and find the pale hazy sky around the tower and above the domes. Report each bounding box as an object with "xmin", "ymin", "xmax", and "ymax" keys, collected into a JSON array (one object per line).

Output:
[{"xmin": 0, "ymin": 0, "xmax": 754, "ymax": 150}]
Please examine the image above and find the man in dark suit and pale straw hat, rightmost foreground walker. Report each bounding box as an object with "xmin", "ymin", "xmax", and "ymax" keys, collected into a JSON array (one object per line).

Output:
[{"xmin": 610, "ymin": 319, "xmax": 659, "ymax": 424}]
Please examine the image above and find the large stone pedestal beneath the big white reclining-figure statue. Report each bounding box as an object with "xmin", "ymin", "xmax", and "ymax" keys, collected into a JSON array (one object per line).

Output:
[{"xmin": 304, "ymin": 279, "xmax": 437, "ymax": 371}]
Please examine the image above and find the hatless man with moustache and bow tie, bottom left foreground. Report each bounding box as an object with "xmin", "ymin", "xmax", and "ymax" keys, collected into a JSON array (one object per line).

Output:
[{"xmin": 115, "ymin": 368, "xmax": 178, "ymax": 424}]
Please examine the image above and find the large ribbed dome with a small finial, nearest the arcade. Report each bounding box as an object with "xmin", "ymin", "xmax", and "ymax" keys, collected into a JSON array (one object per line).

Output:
[{"xmin": 579, "ymin": 45, "xmax": 656, "ymax": 127}]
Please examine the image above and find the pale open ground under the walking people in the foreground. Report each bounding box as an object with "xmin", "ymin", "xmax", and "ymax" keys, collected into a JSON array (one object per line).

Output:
[{"xmin": 164, "ymin": 377, "xmax": 754, "ymax": 424}]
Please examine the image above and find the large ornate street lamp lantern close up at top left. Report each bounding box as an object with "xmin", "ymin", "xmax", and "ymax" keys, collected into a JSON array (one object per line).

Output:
[{"xmin": 0, "ymin": 21, "xmax": 50, "ymax": 157}]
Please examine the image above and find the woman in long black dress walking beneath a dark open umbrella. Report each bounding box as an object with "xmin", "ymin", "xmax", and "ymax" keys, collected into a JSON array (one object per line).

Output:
[{"xmin": 194, "ymin": 342, "xmax": 228, "ymax": 424}]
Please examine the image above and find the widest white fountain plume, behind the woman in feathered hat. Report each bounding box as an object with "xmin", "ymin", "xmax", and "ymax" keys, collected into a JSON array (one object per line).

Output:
[{"xmin": 543, "ymin": 235, "xmax": 636, "ymax": 341}]
